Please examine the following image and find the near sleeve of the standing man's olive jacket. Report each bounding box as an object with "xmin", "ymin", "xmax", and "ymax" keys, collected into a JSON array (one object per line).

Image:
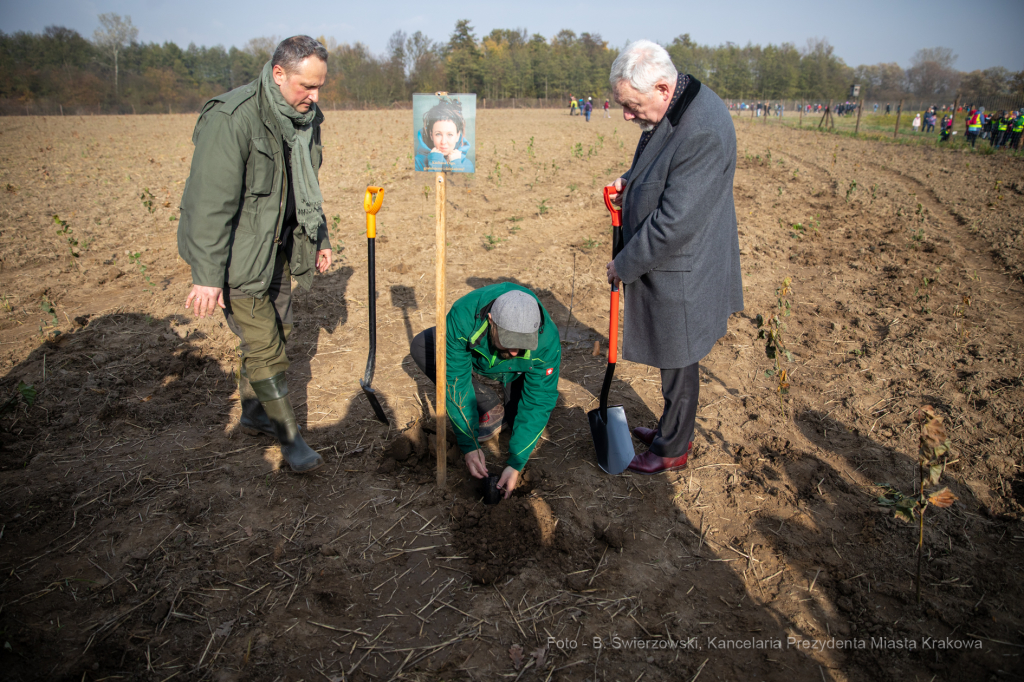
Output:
[{"xmin": 178, "ymin": 110, "xmax": 249, "ymax": 287}]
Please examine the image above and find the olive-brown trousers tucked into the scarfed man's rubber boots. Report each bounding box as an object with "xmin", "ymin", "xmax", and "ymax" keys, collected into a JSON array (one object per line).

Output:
[{"xmin": 224, "ymin": 250, "xmax": 292, "ymax": 381}]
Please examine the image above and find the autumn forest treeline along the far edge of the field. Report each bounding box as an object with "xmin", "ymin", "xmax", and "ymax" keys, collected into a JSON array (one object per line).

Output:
[{"xmin": 0, "ymin": 14, "xmax": 1024, "ymax": 114}]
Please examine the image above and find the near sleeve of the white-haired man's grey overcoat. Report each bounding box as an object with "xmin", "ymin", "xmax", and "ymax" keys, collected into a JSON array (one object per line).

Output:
[{"xmin": 614, "ymin": 129, "xmax": 732, "ymax": 284}]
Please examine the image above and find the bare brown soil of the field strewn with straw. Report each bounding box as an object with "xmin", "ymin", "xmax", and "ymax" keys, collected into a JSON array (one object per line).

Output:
[{"xmin": 0, "ymin": 111, "xmax": 1024, "ymax": 681}]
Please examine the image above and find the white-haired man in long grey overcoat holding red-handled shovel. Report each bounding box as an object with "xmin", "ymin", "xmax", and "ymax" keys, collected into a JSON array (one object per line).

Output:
[{"xmin": 607, "ymin": 40, "xmax": 743, "ymax": 474}]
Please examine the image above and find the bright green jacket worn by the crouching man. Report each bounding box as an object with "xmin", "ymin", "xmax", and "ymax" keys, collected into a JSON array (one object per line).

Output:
[{"xmin": 445, "ymin": 282, "xmax": 562, "ymax": 471}]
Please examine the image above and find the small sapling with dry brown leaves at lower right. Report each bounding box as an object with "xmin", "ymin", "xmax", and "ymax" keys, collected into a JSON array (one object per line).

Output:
[{"xmin": 879, "ymin": 404, "xmax": 956, "ymax": 604}]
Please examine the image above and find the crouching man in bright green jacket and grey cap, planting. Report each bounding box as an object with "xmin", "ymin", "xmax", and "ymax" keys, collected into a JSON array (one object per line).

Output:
[{"xmin": 411, "ymin": 282, "xmax": 562, "ymax": 498}]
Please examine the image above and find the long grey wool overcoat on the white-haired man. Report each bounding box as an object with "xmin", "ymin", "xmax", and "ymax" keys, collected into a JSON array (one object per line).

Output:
[{"xmin": 614, "ymin": 77, "xmax": 743, "ymax": 369}]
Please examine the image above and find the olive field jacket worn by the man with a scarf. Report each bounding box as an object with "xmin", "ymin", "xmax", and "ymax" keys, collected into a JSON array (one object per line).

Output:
[{"xmin": 178, "ymin": 78, "xmax": 331, "ymax": 297}]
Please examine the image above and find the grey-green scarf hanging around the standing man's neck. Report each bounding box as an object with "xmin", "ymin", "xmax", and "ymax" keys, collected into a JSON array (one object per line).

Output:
[{"xmin": 260, "ymin": 61, "xmax": 325, "ymax": 242}]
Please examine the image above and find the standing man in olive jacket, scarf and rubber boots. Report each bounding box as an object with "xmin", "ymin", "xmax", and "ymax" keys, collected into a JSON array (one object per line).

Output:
[{"xmin": 178, "ymin": 36, "xmax": 331, "ymax": 472}]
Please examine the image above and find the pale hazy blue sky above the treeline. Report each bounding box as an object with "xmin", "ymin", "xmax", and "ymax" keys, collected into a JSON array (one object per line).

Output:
[{"xmin": 0, "ymin": 0, "xmax": 1024, "ymax": 72}]
